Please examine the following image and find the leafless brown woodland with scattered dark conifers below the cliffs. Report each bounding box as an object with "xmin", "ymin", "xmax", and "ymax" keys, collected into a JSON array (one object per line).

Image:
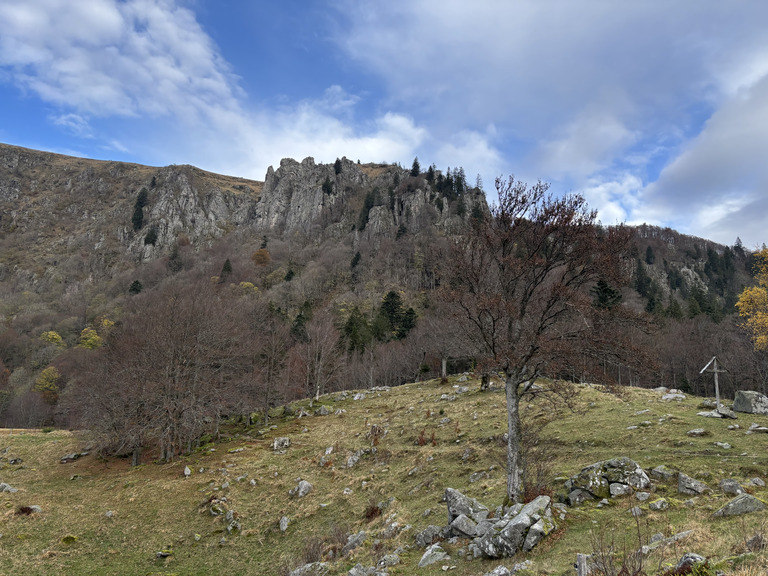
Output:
[{"xmin": 0, "ymin": 151, "xmax": 768, "ymax": 463}]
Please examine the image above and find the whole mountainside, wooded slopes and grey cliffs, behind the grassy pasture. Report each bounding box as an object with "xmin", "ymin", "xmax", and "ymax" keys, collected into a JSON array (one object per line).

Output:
[{"xmin": 0, "ymin": 146, "xmax": 768, "ymax": 461}]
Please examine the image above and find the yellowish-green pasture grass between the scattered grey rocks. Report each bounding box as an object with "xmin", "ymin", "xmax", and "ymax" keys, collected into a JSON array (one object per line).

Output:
[{"xmin": 0, "ymin": 378, "xmax": 768, "ymax": 576}]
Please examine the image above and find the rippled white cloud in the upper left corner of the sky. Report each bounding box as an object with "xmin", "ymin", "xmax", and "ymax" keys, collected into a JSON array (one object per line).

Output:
[{"xmin": 0, "ymin": 0, "xmax": 237, "ymax": 118}]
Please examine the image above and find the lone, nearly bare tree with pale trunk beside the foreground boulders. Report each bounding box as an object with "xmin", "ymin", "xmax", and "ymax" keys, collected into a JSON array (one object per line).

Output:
[{"xmin": 447, "ymin": 177, "xmax": 630, "ymax": 501}]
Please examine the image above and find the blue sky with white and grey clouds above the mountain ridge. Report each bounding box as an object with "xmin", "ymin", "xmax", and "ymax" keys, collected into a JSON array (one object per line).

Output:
[{"xmin": 0, "ymin": 0, "xmax": 768, "ymax": 249}]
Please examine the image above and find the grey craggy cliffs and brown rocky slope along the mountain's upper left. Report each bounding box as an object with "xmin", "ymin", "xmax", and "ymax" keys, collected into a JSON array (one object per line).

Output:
[{"xmin": 0, "ymin": 144, "xmax": 488, "ymax": 289}]
